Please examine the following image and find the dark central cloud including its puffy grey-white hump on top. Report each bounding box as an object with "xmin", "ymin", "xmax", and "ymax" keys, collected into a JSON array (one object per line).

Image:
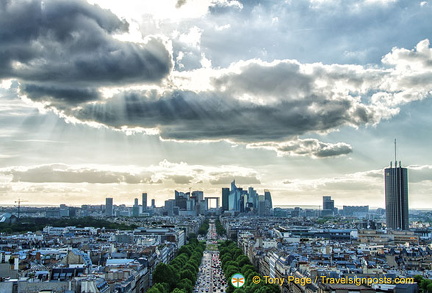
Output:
[{"xmin": 66, "ymin": 57, "xmax": 381, "ymax": 143}]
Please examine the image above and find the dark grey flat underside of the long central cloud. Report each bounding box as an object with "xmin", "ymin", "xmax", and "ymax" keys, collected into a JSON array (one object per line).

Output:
[{"xmin": 71, "ymin": 92, "xmax": 373, "ymax": 141}]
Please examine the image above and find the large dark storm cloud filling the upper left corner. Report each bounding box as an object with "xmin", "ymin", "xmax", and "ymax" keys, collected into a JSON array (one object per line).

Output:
[{"xmin": 0, "ymin": 0, "xmax": 172, "ymax": 86}]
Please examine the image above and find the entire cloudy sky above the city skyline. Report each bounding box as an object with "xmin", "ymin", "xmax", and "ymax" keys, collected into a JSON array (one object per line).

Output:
[{"xmin": 0, "ymin": 0, "xmax": 432, "ymax": 209}]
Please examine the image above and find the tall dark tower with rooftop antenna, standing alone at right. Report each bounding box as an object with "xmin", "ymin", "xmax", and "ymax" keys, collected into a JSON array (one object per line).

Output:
[{"xmin": 384, "ymin": 140, "xmax": 409, "ymax": 230}]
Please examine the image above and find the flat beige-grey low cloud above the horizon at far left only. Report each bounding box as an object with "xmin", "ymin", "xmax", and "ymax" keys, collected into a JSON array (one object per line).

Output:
[{"xmin": 2, "ymin": 164, "xmax": 152, "ymax": 184}]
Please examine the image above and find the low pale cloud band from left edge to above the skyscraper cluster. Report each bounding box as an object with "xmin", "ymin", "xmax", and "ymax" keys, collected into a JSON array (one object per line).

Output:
[{"xmin": 0, "ymin": 160, "xmax": 260, "ymax": 186}]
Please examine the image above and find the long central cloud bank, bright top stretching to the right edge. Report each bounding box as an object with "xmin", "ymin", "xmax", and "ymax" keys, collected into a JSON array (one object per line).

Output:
[{"xmin": 16, "ymin": 41, "xmax": 432, "ymax": 158}]
